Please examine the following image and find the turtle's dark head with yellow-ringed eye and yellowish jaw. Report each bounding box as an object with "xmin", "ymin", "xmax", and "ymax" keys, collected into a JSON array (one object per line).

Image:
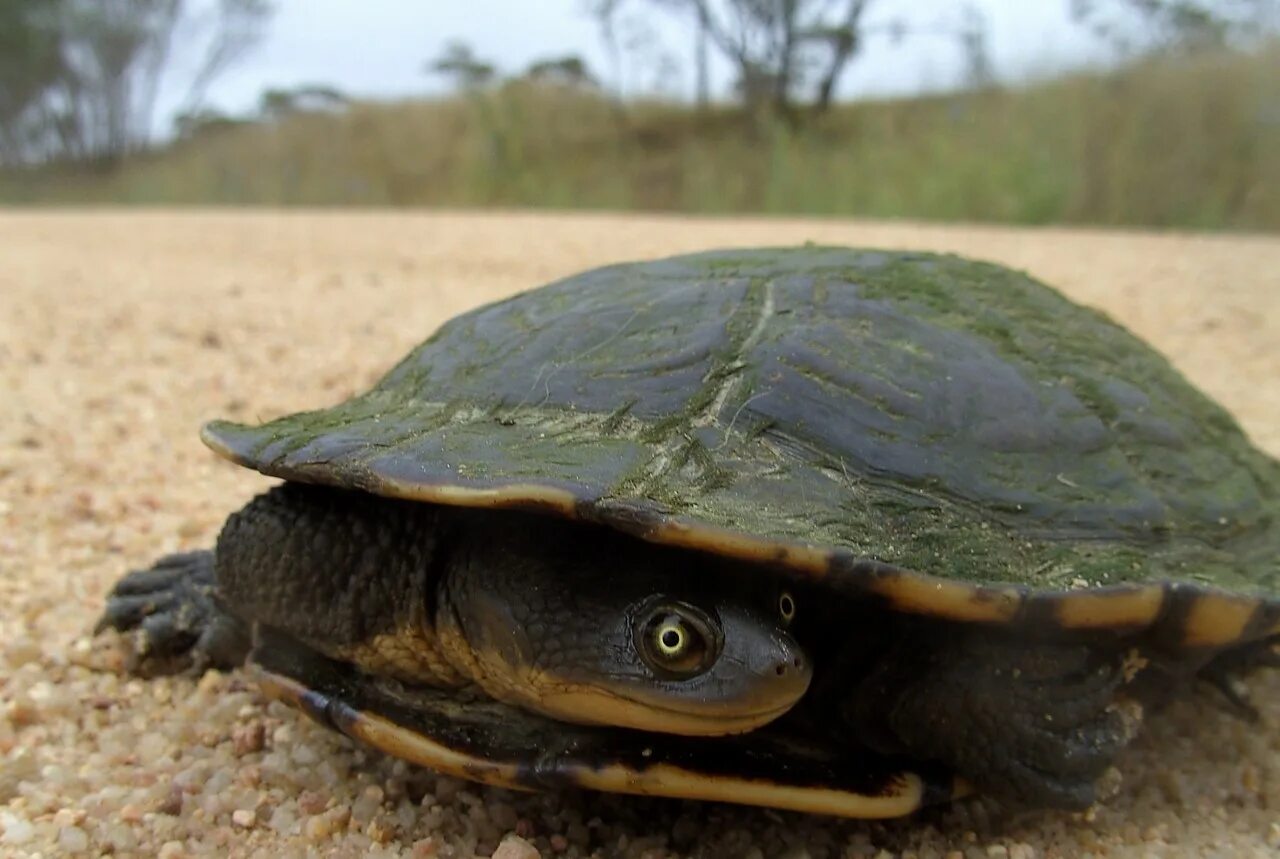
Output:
[{"xmin": 436, "ymin": 524, "xmax": 812, "ymax": 736}]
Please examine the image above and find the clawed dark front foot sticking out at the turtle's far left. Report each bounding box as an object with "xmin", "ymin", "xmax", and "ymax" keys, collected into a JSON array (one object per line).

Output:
[{"xmin": 96, "ymin": 550, "xmax": 250, "ymax": 671}]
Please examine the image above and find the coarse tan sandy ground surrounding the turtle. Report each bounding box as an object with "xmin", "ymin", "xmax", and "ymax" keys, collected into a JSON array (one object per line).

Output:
[{"xmin": 0, "ymin": 213, "xmax": 1280, "ymax": 859}]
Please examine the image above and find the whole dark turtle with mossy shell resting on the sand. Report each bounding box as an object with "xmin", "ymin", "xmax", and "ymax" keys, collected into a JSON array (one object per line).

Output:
[{"xmin": 100, "ymin": 246, "xmax": 1280, "ymax": 818}]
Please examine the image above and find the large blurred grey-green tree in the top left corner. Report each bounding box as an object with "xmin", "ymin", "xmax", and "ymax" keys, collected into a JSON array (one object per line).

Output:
[{"xmin": 0, "ymin": 0, "xmax": 271, "ymax": 166}]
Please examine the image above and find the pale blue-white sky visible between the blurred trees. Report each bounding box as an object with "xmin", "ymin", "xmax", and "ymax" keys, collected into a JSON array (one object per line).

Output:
[{"xmin": 161, "ymin": 0, "xmax": 1107, "ymax": 126}]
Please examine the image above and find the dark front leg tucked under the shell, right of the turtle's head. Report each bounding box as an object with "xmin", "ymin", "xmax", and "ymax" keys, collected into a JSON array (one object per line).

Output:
[{"xmin": 850, "ymin": 627, "xmax": 1139, "ymax": 809}]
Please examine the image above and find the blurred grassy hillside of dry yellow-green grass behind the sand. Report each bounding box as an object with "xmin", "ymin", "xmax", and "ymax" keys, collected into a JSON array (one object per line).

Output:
[{"xmin": 0, "ymin": 46, "xmax": 1280, "ymax": 230}]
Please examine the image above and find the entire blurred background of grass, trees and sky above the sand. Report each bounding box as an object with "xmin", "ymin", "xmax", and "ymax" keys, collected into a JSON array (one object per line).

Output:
[{"xmin": 0, "ymin": 0, "xmax": 1280, "ymax": 232}]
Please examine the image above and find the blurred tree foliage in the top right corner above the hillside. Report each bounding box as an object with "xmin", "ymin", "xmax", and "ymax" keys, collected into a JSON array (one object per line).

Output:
[{"xmin": 1069, "ymin": 0, "xmax": 1280, "ymax": 55}]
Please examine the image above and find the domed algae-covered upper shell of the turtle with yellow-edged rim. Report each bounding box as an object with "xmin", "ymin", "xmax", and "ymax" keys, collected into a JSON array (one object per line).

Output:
[{"xmin": 204, "ymin": 247, "xmax": 1280, "ymax": 648}]
